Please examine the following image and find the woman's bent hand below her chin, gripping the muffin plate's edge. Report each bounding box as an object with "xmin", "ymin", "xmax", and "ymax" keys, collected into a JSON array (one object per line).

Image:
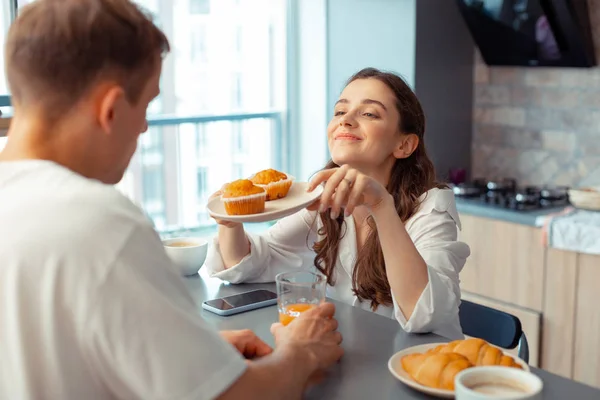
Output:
[{"xmin": 307, "ymin": 165, "xmax": 394, "ymax": 219}]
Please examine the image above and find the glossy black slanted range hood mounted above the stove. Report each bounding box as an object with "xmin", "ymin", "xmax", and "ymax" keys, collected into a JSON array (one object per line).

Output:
[{"xmin": 456, "ymin": 0, "xmax": 596, "ymax": 67}]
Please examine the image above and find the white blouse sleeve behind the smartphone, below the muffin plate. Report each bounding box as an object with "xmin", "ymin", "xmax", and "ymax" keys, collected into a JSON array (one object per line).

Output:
[{"xmin": 205, "ymin": 210, "xmax": 316, "ymax": 283}]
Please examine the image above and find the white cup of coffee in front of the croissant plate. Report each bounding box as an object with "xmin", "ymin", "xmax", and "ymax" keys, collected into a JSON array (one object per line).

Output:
[{"xmin": 454, "ymin": 367, "xmax": 544, "ymax": 400}]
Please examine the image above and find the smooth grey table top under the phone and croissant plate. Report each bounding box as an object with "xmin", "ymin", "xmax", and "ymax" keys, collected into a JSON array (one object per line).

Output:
[{"xmin": 186, "ymin": 269, "xmax": 600, "ymax": 400}]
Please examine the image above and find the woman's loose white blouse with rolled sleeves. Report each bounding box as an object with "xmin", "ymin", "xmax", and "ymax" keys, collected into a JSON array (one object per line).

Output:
[{"xmin": 205, "ymin": 189, "xmax": 470, "ymax": 339}]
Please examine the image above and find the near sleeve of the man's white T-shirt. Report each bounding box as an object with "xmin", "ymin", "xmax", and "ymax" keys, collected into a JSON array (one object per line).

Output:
[{"xmin": 84, "ymin": 225, "xmax": 246, "ymax": 399}]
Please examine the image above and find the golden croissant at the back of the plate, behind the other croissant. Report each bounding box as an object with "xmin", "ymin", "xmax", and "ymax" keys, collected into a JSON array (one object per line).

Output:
[{"xmin": 429, "ymin": 338, "xmax": 522, "ymax": 369}]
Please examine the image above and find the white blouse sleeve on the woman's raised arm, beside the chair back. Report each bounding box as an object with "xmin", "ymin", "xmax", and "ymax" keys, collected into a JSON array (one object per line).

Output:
[{"xmin": 392, "ymin": 192, "xmax": 470, "ymax": 332}]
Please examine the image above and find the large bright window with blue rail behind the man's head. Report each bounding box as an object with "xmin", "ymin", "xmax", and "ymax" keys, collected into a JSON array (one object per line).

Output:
[{"xmin": 0, "ymin": 0, "xmax": 288, "ymax": 234}]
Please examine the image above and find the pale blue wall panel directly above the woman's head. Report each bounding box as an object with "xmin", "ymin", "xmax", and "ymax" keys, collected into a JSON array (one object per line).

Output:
[{"xmin": 327, "ymin": 0, "xmax": 417, "ymax": 113}]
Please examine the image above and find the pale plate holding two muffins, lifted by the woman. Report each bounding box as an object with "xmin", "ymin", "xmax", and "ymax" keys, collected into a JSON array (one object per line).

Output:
[{"xmin": 206, "ymin": 182, "xmax": 323, "ymax": 222}]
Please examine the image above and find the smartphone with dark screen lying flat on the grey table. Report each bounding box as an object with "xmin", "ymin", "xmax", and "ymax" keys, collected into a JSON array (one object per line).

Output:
[{"xmin": 202, "ymin": 289, "xmax": 277, "ymax": 316}]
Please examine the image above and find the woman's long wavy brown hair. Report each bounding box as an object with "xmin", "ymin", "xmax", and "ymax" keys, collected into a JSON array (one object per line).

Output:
[{"xmin": 313, "ymin": 68, "xmax": 444, "ymax": 310}]
